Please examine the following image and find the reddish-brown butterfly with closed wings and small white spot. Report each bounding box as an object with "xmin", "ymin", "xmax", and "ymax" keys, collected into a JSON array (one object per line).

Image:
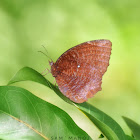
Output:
[{"xmin": 50, "ymin": 40, "xmax": 112, "ymax": 103}]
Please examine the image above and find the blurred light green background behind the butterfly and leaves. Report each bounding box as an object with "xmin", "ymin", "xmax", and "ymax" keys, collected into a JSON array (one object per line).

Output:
[{"xmin": 0, "ymin": 0, "xmax": 140, "ymax": 138}]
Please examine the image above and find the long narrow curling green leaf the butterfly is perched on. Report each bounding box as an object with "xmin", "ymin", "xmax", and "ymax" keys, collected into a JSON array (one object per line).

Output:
[{"xmin": 9, "ymin": 67, "xmax": 126, "ymax": 140}]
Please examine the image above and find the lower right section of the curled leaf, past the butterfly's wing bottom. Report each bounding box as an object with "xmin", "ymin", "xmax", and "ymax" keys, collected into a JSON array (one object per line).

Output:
[{"xmin": 75, "ymin": 102, "xmax": 126, "ymax": 140}]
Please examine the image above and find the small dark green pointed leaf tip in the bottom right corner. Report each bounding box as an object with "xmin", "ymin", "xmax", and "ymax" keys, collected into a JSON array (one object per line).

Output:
[{"xmin": 123, "ymin": 117, "xmax": 140, "ymax": 140}]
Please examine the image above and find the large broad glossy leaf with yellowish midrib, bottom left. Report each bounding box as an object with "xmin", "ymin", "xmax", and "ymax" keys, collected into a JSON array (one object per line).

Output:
[{"xmin": 0, "ymin": 86, "xmax": 91, "ymax": 140}]
